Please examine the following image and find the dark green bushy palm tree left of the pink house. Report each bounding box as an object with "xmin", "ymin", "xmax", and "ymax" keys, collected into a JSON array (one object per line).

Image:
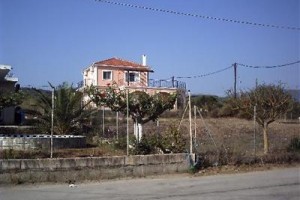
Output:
[{"xmin": 35, "ymin": 83, "xmax": 91, "ymax": 135}]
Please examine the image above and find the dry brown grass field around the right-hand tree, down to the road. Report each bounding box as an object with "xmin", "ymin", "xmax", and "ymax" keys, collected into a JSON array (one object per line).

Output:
[{"xmin": 154, "ymin": 118, "xmax": 300, "ymax": 166}]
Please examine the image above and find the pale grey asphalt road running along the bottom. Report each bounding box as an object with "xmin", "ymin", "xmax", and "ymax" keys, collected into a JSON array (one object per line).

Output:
[{"xmin": 0, "ymin": 168, "xmax": 300, "ymax": 200}]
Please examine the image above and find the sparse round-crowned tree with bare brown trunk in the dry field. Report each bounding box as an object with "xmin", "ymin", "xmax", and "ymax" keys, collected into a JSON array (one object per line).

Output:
[{"xmin": 236, "ymin": 84, "xmax": 293, "ymax": 154}]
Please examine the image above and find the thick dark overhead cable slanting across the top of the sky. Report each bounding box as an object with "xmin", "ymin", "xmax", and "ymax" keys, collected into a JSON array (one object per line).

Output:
[{"xmin": 95, "ymin": 0, "xmax": 300, "ymax": 31}]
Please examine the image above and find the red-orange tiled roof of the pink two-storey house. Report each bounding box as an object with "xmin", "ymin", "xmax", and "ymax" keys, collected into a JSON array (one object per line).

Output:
[{"xmin": 94, "ymin": 58, "xmax": 153, "ymax": 72}]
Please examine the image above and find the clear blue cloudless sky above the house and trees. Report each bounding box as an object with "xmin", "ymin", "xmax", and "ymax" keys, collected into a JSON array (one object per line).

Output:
[{"xmin": 0, "ymin": 0, "xmax": 300, "ymax": 95}]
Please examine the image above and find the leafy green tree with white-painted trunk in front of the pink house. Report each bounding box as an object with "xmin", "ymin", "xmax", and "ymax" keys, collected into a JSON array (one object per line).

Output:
[{"xmin": 86, "ymin": 84, "xmax": 177, "ymax": 142}]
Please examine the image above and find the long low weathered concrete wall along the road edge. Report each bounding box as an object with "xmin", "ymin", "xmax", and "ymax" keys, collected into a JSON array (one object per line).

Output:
[{"xmin": 0, "ymin": 154, "xmax": 191, "ymax": 184}]
